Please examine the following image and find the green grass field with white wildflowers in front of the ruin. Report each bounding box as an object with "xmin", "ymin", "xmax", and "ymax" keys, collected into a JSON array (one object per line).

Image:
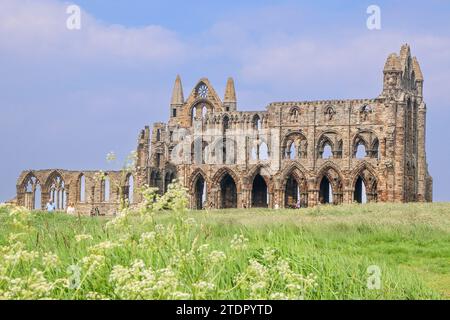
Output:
[{"xmin": 0, "ymin": 203, "xmax": 450, "ymax": 299}]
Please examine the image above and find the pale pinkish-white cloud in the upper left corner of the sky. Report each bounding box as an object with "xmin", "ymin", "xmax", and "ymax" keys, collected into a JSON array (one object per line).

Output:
[{"xmin": 0, "ymin": 0, "xmax": 186, "ymax": 63}]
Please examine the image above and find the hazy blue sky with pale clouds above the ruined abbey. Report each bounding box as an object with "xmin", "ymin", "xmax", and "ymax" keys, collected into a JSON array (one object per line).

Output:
[{"xmin": 0, "ymin": 0, "xmax": 450, "ymax": 201}]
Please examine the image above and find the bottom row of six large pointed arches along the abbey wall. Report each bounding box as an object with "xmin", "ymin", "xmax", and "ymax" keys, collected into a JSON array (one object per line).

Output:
[{"xmin": 185, "ymin": 166, "xmax": 378, "ymax": 210}]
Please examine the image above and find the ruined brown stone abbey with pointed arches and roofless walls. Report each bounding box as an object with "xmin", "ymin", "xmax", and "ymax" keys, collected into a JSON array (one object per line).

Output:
[{"xmin": 16, "ymin": 45, "xmax": 432, "ymax": 214}]
